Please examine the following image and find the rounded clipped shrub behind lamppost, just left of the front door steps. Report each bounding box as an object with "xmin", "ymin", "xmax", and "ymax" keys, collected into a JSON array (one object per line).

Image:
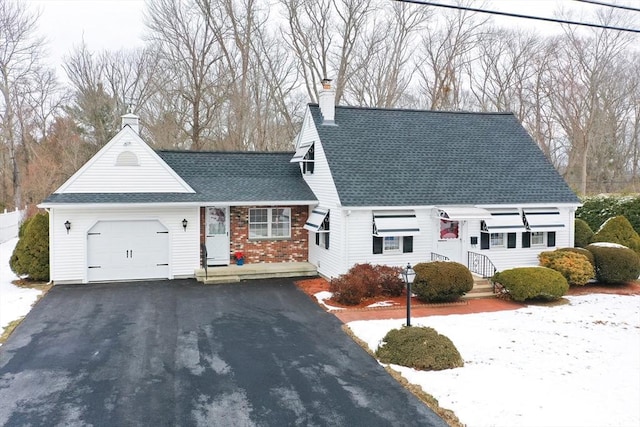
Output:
[{"xmin": 412, "ymin": 261, "xmax": 473, "ymax": 302}]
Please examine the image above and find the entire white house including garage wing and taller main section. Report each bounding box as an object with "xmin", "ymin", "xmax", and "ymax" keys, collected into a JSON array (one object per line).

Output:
[{"xmin": 40, "ymin": 81, "xmax": 580, "ymax": 283}]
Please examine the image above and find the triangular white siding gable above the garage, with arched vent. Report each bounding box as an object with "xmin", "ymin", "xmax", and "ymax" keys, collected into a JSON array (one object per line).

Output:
[{"xmin": 56, "ymin": 127, "xmax": 193, "ymax": 193}]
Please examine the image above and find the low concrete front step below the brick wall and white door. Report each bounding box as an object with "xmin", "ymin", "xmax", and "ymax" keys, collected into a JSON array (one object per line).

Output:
[{"xmin": 196, "ymin": 262, "xmax": 318, "ymax": 284}]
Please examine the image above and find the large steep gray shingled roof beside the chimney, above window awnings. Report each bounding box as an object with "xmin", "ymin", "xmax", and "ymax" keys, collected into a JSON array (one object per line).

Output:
[{"xmin": 309, "ymin": 104, "xmax": 580, "ymax": 206}]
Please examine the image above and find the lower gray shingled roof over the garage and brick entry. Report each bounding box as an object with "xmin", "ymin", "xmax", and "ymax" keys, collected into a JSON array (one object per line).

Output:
[{"xmin": 43, "ymin": 151, "xmax": 316, "ymax": 203}]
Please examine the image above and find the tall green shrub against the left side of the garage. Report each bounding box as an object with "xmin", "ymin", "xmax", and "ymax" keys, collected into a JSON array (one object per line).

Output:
[{"xmin": 9, "ymin": 213, "xmax": 49, "ymax": 281}]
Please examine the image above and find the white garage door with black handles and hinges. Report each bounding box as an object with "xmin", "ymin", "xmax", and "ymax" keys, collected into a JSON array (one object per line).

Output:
[{"xmin": 87, "ymin": 221, "xmax": 169, "ymax": 282}]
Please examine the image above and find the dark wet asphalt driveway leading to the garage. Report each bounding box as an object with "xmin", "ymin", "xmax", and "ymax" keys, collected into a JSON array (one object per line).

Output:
[{"xmin": 0, "ymin": 280, "xmax": 446, "ymax": 426}]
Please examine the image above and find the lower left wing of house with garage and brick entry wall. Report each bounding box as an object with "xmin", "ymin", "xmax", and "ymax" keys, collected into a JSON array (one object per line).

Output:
[{"xmin": 40, "ymin": 114, "xmax": 317, "ymax": 284}]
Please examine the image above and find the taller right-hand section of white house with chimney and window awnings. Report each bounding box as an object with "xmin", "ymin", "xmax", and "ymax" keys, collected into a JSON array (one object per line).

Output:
[{"xmin": 291, "ymin": 81, "xmax": 580, "ymax": 277}]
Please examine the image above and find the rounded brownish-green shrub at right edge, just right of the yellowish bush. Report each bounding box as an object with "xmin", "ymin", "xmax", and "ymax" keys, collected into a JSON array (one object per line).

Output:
[{"xmin": 587, "ymin": 243, "xmax": 640, "ymax": 283}]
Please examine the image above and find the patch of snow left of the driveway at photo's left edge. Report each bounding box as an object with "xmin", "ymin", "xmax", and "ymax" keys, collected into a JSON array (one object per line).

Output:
[{"xmin": 0, "ymin": 237, "xmax": 42, "ymax": 345}]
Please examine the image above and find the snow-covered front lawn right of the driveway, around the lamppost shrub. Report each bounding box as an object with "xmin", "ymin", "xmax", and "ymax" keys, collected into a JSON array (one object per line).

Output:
[{"xmin": 349, "ymin": 294, "xmax": 640, "ymax": 427}]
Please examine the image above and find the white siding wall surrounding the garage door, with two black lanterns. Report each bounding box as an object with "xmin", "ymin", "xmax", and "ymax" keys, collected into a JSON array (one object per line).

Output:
[{"xmin": 49, "ymin": 205, "xmax": 200, "ymax": 283}]
